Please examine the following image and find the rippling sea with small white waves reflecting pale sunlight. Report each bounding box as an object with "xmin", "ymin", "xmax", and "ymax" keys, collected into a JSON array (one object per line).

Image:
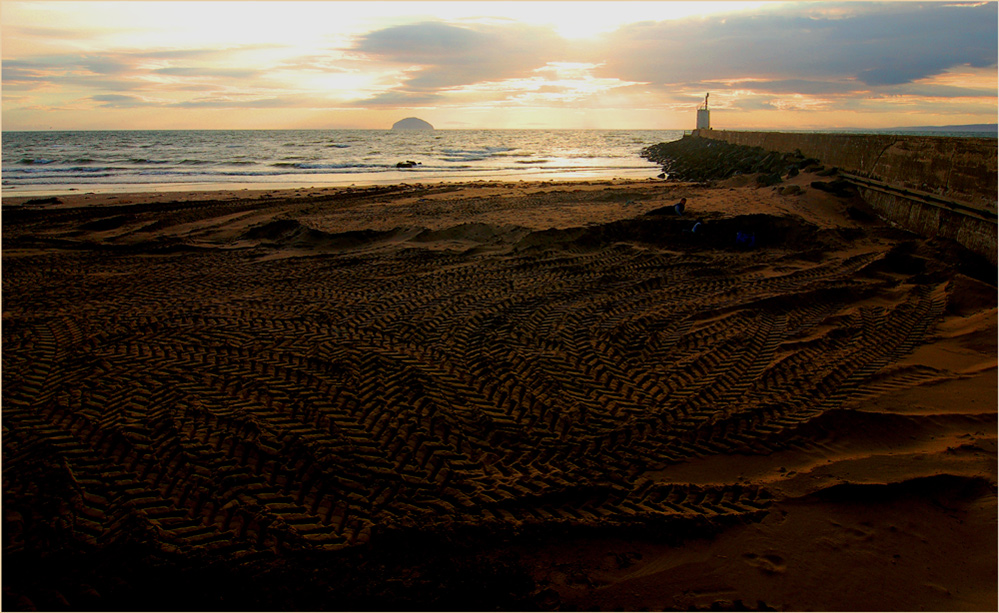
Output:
[{"xmin": 2, "ymin": 130, "xmax": 684, "ymax": 196}]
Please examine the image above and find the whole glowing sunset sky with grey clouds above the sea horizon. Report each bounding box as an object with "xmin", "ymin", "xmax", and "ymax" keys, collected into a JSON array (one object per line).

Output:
[{"xmin": 0, "ymin": 0, "xmax": 999, "ymax": 131}]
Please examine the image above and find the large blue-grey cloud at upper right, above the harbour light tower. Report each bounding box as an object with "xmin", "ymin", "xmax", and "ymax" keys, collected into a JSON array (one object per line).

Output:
[{"xmin": 595, "ymin": 2, "xmax": 997, "ymax": 93}]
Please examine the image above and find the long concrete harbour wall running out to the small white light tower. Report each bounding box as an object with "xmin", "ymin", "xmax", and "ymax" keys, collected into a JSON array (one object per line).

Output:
[{"xmin": 694, "ymin": 130, "xmax": 999, "ymax": 264}]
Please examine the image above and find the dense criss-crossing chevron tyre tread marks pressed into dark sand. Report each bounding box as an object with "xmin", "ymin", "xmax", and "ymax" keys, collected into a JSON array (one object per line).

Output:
[{"xmin": 3, "ymin": 219, "xmax": 946, "ymax": 556}]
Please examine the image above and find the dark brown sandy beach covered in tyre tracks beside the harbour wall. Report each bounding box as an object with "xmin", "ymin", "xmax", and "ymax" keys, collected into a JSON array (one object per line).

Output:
[{"xmin": 2, "ymin": 172, "xmax": 999, "ymax": 611}]
